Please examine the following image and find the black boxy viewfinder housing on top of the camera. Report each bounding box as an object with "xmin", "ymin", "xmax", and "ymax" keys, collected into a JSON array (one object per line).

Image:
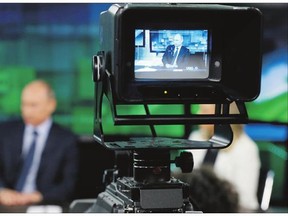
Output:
[{"xmin": 96, "ymin": 4, "xmax": 262, "ymax": 103}]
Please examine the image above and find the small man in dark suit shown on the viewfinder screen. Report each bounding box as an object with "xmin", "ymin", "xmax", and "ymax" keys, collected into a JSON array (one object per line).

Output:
[{"xmin": 162, "ymin": 34, "xmax": 190, "ymax": 69}]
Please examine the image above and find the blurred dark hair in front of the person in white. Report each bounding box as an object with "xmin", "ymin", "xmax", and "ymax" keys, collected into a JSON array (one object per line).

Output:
[{"xmin": 175, "ymin": 165, "xmax": 239, "ymax": 213}]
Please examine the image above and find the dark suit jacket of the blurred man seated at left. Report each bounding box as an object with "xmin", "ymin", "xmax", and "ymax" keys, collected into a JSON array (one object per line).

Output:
[{"xmin": 0, "ymin": 121, "xmax": 78, "ymax": 201}]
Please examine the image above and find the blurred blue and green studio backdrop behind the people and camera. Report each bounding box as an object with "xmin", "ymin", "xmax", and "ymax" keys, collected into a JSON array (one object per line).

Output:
[{"xmin": 0, "ymin": 3, "xmax": 288, "ymax": 211}]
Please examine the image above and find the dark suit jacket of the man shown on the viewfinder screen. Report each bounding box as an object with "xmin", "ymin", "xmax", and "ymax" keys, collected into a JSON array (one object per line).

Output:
[{"xmin": 162, "ymin": 45, "xmax": 190, "ymax": 69}]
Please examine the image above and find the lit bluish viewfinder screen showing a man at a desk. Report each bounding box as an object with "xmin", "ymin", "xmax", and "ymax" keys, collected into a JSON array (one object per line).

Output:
[{"xmin": 134, "ymin": 29, "xmax": 210, "ymax": 81}]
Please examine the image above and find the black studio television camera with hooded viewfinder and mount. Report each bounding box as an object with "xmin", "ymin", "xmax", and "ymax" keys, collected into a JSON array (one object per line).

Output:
[{"xmin": 73, "ymin": 3, "xmax": 262, "ymax": 213}]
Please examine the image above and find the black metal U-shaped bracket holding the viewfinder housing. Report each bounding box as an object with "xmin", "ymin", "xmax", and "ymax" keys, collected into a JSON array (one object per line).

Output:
[{"xmin": 93, "ymin": 52, "xmax": 248, "ymax": 150}]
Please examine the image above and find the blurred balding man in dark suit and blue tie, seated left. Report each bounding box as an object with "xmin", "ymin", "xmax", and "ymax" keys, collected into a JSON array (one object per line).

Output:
[{"xmin": 0, "ymin": 80, "xmax": 78, "ymax": 206}]
